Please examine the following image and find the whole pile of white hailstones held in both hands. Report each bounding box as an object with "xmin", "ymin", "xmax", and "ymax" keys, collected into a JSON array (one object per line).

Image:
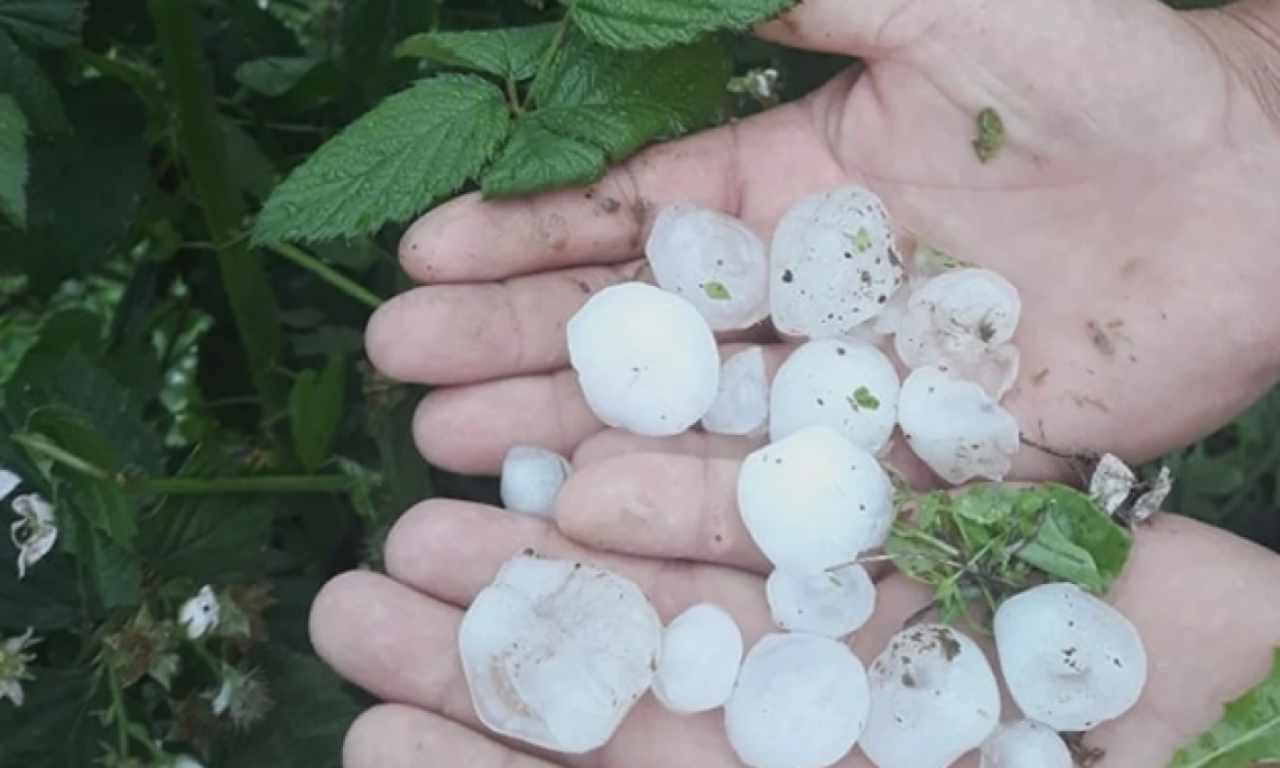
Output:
[{"xmin": 458, "ymin": 187, "xmax": 1147, "ymax": 768}]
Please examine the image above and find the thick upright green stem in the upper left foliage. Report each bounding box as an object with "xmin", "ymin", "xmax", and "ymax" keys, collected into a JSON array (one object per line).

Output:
[{"xmin": 147, "ymin": 0, "xmax": 283, "ymax": 417}]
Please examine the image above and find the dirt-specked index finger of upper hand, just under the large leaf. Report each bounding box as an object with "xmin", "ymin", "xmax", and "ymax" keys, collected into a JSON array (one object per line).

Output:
[{"xmin": 401, "ymin": 101, "xmax": 841, "ymax": 283}]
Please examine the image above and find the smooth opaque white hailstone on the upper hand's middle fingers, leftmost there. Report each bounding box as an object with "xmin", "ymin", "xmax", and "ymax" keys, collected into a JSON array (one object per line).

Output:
[{"xmin": 567, "ymin": 283, "xmax": 721, "ymax": 438}]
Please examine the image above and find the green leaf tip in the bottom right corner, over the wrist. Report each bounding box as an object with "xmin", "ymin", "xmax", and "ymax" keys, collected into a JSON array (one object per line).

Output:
[{"xmin": 1167, "ymin": 648, "xmax": 1280, "ymax": 768}]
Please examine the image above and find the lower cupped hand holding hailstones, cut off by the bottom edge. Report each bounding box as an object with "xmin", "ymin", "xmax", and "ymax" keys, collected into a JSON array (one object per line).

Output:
[{"xmin": 311, "ymin": 433, "xmax": 1280, "ymax": 768}]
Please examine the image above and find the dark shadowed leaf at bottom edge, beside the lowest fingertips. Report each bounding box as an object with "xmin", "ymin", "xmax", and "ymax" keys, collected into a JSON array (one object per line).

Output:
[{"xmin": 215, "ymin": 648, "xmax": 360, "ymax": 768}]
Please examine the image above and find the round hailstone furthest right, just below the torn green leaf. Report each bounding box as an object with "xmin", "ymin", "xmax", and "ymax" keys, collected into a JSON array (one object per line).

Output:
[{"xmin": 993, "ymin": 582, "xmax": 1147, "ymax": 732}]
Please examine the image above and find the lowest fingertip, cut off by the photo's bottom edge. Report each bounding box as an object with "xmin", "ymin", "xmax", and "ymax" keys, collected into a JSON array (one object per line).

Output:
[{"xmin": 342, "ymin": 704, "xmax": 556, "ymax": 768}]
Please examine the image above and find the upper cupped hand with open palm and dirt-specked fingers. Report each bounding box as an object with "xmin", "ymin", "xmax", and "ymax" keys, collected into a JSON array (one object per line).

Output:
[{"xmin": 367, "ymin": 0, "xmax": 1280, "ymax": 479}]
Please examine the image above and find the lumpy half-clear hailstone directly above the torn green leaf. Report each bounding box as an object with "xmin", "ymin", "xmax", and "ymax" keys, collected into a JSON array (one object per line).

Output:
[{"xmin": 897, "ymin": 366, "xmax": 1021, "ymax": 485}]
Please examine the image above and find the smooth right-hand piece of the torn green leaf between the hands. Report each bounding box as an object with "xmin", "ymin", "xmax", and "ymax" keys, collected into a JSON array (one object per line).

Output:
[{"xmin": 1018, "ymin": 484, "xmax": 1133, "ymax": 595}]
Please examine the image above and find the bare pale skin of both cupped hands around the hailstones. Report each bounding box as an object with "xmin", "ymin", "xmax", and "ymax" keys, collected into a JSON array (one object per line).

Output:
[{"xmin": 312, "ymin": 0, "xmax": 1280, "ymax": 768}]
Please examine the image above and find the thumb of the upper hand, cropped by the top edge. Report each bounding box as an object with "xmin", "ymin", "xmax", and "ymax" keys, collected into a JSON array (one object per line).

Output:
[{"xmin": 755, "ymin": 0, "xmax": 967, "ymax": 59}]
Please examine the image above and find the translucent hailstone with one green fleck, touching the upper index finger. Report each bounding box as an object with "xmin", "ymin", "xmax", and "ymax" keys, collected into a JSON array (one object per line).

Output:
[{"xmin": 645, "ymin": 202, "xmax": 769, "ymax": 330}]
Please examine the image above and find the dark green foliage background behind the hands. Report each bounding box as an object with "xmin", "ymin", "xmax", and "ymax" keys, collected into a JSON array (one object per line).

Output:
[{"xmin": 0, "ymin": 0, "xmax": 1264, "ymax": 768}]
